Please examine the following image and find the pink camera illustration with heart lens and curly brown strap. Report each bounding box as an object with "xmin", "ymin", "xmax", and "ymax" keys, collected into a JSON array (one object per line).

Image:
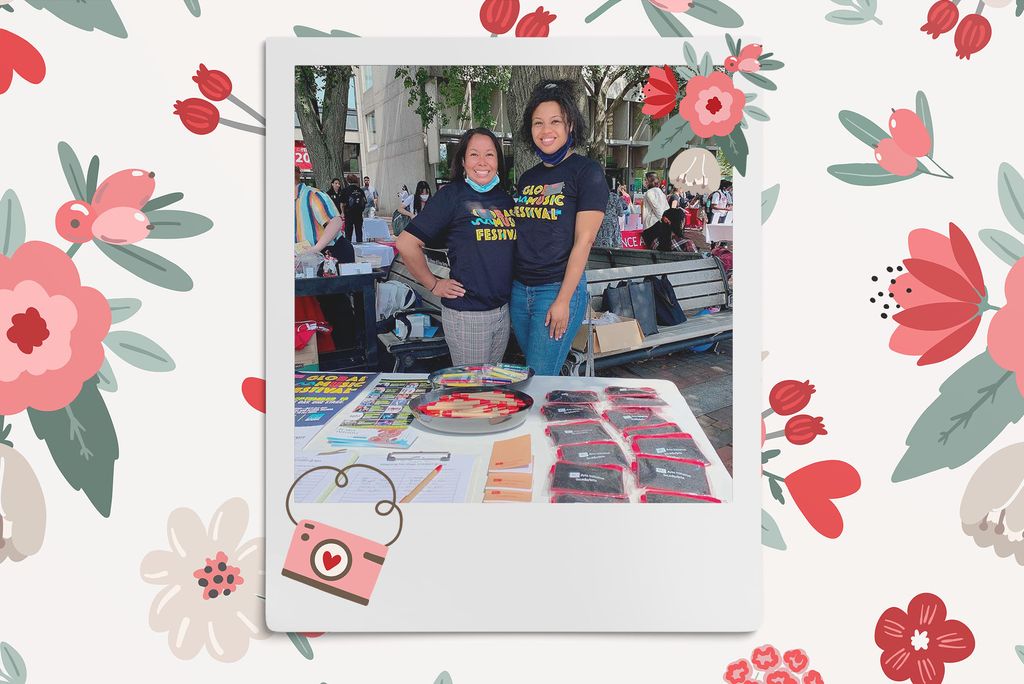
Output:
[{"xmin": 281, "ymin": 464, "xmax": 402, "ymax": 605}]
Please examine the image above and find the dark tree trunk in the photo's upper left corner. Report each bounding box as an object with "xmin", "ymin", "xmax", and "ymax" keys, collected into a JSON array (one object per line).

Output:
[{"xmin": 295, "ymin": 67, "xmax": 352, "ymax": 189}]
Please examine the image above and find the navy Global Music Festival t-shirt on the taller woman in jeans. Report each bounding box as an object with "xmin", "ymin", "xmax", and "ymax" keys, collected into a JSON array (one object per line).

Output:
[{"xmin": 514, "ymin": 153, "xmax": 608, "ymax": 286}]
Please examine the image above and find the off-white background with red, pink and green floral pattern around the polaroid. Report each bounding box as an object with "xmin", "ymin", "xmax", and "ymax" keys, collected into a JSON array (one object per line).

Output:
[{"xmin": 0, "ymin": 0, "xmax": 1024, "ymax": 684}]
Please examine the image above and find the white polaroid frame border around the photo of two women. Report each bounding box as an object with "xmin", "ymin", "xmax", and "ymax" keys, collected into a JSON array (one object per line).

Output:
[{"xmin": 266, "ymin": 37, "xmax": 763, "ymax": 632}]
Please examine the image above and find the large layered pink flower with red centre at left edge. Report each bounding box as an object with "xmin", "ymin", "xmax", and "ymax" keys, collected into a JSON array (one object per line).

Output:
[{"xmin": 0, "ymin": 242, "xmax": 111, "ymax": 415}]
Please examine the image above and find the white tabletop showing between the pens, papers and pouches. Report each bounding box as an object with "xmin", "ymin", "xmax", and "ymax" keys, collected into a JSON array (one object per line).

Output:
[{"xmin": 305, "ymin": 373, "xmax": 732, "ymax": 504}]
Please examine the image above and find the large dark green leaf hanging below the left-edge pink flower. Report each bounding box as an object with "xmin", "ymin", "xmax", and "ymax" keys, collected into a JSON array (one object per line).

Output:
[{"xmin": 28, "ymin": 378, "xmax": 118, "ymax": 517}]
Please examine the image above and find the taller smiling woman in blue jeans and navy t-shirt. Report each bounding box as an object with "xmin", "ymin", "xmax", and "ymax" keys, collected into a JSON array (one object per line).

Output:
[{"xmin": 510, "ymin": 80, "xmax": 609, "ymax": 375}]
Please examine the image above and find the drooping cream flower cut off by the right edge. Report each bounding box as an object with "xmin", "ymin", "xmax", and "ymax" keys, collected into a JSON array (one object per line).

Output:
[{"xmin": 961, "ymin": 443, "xmax": 1024, "ymax": 565}]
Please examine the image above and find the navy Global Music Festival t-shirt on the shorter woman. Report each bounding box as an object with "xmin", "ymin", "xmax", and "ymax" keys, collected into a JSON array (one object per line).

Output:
[{"xmin": 406, "ymin": 180, "xmax": 516, "ymax": 311}]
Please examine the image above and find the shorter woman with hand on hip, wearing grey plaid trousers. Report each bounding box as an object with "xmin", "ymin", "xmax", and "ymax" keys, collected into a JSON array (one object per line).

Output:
[{"xmin": 396, "ymin": 128, "xmax": 516, "ymax": 366}]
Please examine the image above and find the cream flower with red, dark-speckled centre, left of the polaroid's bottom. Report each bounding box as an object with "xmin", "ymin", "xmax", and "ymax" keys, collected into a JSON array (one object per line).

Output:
[{"xmin": 141, "ymin": 499, "xmax": 269, "ymax": 662}]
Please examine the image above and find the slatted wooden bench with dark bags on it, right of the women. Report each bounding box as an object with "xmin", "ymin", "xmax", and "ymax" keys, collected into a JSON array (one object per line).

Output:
[{"xmin": 563, "ymin": 257, "xmax": 732, "ymax": 375}]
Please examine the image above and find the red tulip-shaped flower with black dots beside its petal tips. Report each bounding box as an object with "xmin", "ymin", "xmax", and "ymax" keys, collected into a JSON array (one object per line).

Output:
[{"xmin": 889, "ymin": 223, "xmax": 988, "ymax": 366}]
